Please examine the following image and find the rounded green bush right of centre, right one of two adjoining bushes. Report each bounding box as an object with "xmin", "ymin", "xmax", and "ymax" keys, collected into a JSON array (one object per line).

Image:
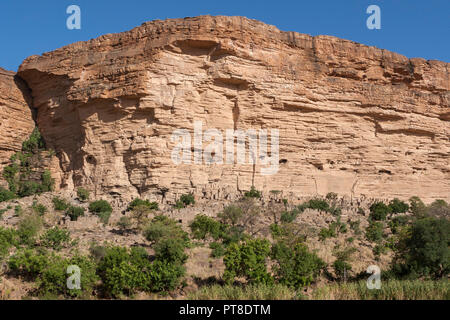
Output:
[{"xmin": 271, "ymin": 243, "xmax": 325, "ymax": 289}]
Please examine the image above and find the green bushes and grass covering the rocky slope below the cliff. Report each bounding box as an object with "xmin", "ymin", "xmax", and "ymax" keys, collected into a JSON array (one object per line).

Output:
[{"xmin": 0, "ymin": 182, "xmax": 450, "ymax": 299}]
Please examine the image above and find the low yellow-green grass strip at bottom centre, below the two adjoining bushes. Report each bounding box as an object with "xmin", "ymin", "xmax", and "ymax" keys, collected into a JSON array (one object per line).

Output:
[{"xmin": 188, "ymin": 284, "xmax": 299, "ymax": 300}]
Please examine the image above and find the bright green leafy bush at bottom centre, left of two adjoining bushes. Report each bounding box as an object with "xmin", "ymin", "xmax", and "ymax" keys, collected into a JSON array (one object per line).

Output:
[{"xmin": 223, "ymin": 239, "xmax": 273, "ymax": 284}]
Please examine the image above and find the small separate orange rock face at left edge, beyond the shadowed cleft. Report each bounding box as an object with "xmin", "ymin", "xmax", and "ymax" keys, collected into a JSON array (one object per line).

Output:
[{"xmin": 0, "ymin": 68, "xmax": 35, "ymax": 176}]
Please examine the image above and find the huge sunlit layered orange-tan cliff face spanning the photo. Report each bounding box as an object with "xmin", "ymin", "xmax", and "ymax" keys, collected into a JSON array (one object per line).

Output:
[{"xmin": 15, "ymin": 16, "xmax": 450, "ymax": 201}]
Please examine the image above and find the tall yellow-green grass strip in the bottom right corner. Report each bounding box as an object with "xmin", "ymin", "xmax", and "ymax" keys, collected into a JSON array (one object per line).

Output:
[{"xmin": 312, "ymin": 280, "xmax": 450, "ymax": 300}]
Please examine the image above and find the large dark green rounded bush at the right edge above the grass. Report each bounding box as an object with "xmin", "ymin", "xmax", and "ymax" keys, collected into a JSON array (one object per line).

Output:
[{"xmin": 394, "ymin": 218, "xmax": 450, "ymax": 278}]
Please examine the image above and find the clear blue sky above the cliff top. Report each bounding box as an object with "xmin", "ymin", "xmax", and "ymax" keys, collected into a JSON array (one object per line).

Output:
[{"xmin": 0, "ymin": 0, "xmax": 450, "ymax": 70}]
